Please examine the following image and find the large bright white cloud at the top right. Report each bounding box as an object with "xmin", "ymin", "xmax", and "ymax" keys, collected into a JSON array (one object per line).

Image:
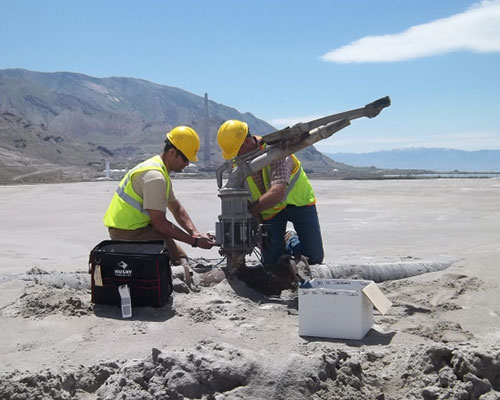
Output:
[{"xmin": 321, "ymin": 0, "xmax": 500, "ymax": 63}]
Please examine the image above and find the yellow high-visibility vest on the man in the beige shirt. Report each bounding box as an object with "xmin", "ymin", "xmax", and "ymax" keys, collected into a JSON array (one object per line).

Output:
[{"xmin": 103, "ymin": 156, "xmax": 171, "ymax": 230}]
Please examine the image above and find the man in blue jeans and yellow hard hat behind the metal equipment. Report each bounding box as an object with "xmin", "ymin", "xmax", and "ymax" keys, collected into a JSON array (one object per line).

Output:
[{"xmin": 217, "ymin": 120, "xmax": 324, "ymax": 265}]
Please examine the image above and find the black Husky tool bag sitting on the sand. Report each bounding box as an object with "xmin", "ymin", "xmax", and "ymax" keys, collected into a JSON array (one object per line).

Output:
[{"xmin": 89, "ymin": 240, "xmax": 172, "ymax": 307}]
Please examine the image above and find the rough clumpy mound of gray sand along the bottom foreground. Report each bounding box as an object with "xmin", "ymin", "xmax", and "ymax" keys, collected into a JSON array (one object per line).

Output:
[{"xmin": 0, "ymin": 340, "xmax": 500, "ymax": 400}]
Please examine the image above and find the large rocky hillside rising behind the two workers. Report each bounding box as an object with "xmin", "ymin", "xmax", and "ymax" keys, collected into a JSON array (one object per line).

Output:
[{"xmin": 0, "ymin": 69, "xmax": 339, "ymax": 181}]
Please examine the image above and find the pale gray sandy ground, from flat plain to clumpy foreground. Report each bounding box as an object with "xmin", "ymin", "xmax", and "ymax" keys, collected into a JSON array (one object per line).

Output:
[{"xmin": 0, "ymin": 179, "xmax": 500, "ymax": 400}]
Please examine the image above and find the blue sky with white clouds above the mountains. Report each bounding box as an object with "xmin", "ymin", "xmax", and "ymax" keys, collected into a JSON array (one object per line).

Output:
[{"xmin": 0, "ymin": 0, "xmax": 500, "ymax": 153}]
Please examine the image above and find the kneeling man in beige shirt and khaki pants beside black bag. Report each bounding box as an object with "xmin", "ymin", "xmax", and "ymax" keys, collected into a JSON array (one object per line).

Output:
[{"xmin": 104, "ymin": 126, "xmax": 215, "ymax": 265}]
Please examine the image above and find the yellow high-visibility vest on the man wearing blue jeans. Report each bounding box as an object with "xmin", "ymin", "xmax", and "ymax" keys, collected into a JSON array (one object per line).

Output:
[{"xmin": 247, "ymin": 141, "xmax": 316, "ymax": 220}]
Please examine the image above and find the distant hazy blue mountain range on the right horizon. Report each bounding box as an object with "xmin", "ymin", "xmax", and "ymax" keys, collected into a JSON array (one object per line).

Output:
[{"xmin": 325, "ymin": 148, "xmax": 500, "ymax": 172}]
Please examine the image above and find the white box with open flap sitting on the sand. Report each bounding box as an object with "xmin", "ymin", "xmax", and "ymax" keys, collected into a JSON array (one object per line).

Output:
[{"xmin": 299, "ymin": 279, "xmax": 392, "ymax": 340}]
